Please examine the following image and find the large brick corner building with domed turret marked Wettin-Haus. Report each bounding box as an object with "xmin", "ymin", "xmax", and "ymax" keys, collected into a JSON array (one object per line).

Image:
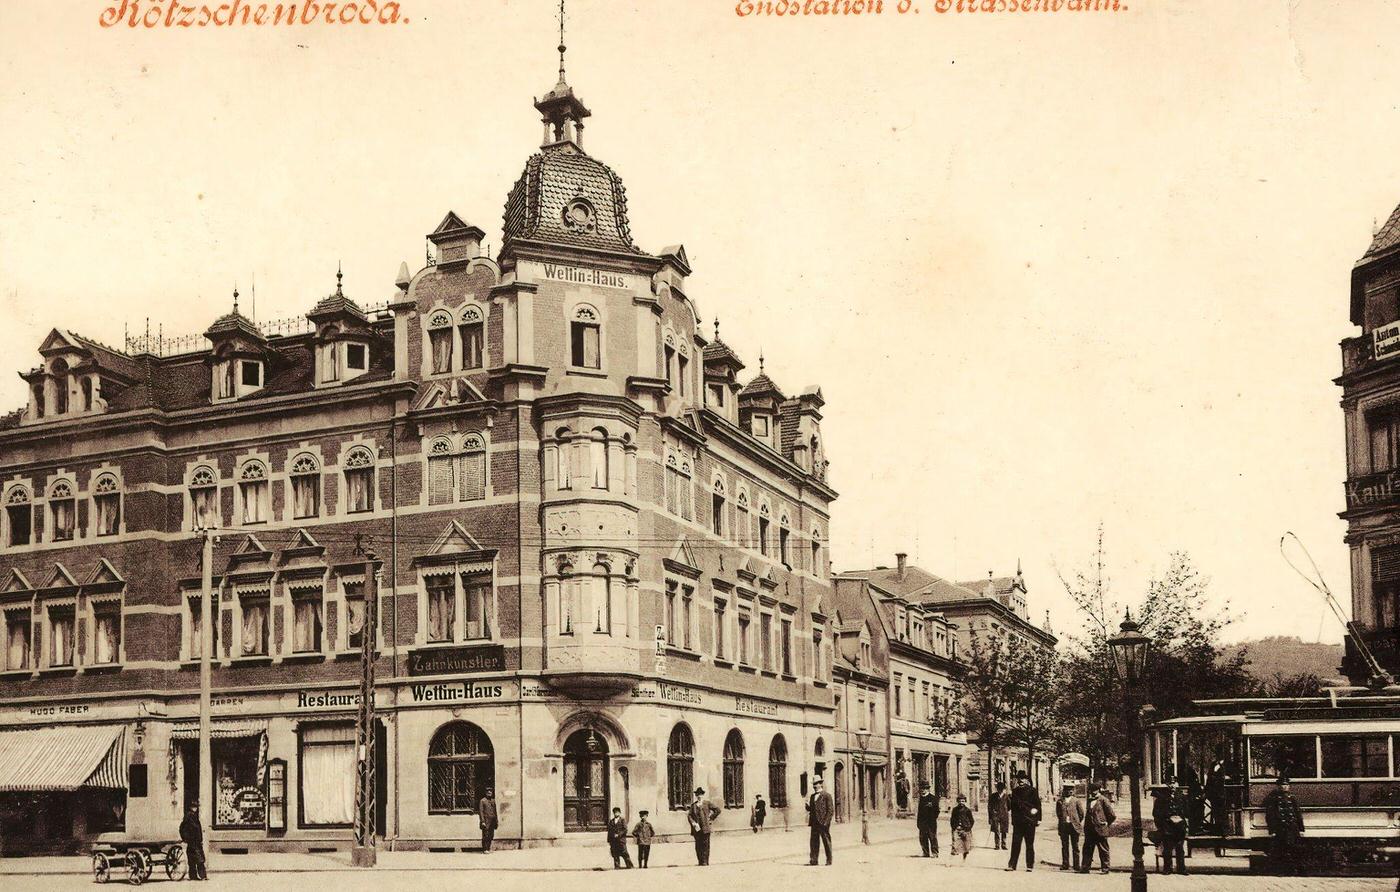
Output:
[{"xmin": 0, "ymin": 57, "xmax": 836, "ymax": 854}]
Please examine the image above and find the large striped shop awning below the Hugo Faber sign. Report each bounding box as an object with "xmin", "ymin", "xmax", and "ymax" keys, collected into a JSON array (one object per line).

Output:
[{"xmin": 0, "ymin": 725, "xmax": 126, "ymax": 793}]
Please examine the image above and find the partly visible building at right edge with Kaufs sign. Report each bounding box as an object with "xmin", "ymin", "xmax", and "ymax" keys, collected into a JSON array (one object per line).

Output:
[{"xmin": 1336, "ymin": 198, "xmax": 1400, "ymax": 685}]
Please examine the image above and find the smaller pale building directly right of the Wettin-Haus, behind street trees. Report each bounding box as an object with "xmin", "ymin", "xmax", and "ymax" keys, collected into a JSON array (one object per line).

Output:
[{"xmin": 833, "ymin": 555, "xmax": 967, "ymax": 812}]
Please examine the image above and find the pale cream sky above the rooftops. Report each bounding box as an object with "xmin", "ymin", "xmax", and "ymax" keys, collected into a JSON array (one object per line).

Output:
[{"xmin": 0, "ymin": 0, "xmax": 1400, "ymax": 641}]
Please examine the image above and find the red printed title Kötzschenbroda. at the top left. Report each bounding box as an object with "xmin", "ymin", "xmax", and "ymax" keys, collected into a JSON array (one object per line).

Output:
[{"xmin": 98, "ymin": 0, "xmax": 409, "ymax": 28}]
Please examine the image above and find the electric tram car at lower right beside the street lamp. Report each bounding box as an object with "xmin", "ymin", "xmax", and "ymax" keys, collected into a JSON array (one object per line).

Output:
[{"xmin": 1144, "ymin": 688, "xmax": 1400, "ymax": 870}]
